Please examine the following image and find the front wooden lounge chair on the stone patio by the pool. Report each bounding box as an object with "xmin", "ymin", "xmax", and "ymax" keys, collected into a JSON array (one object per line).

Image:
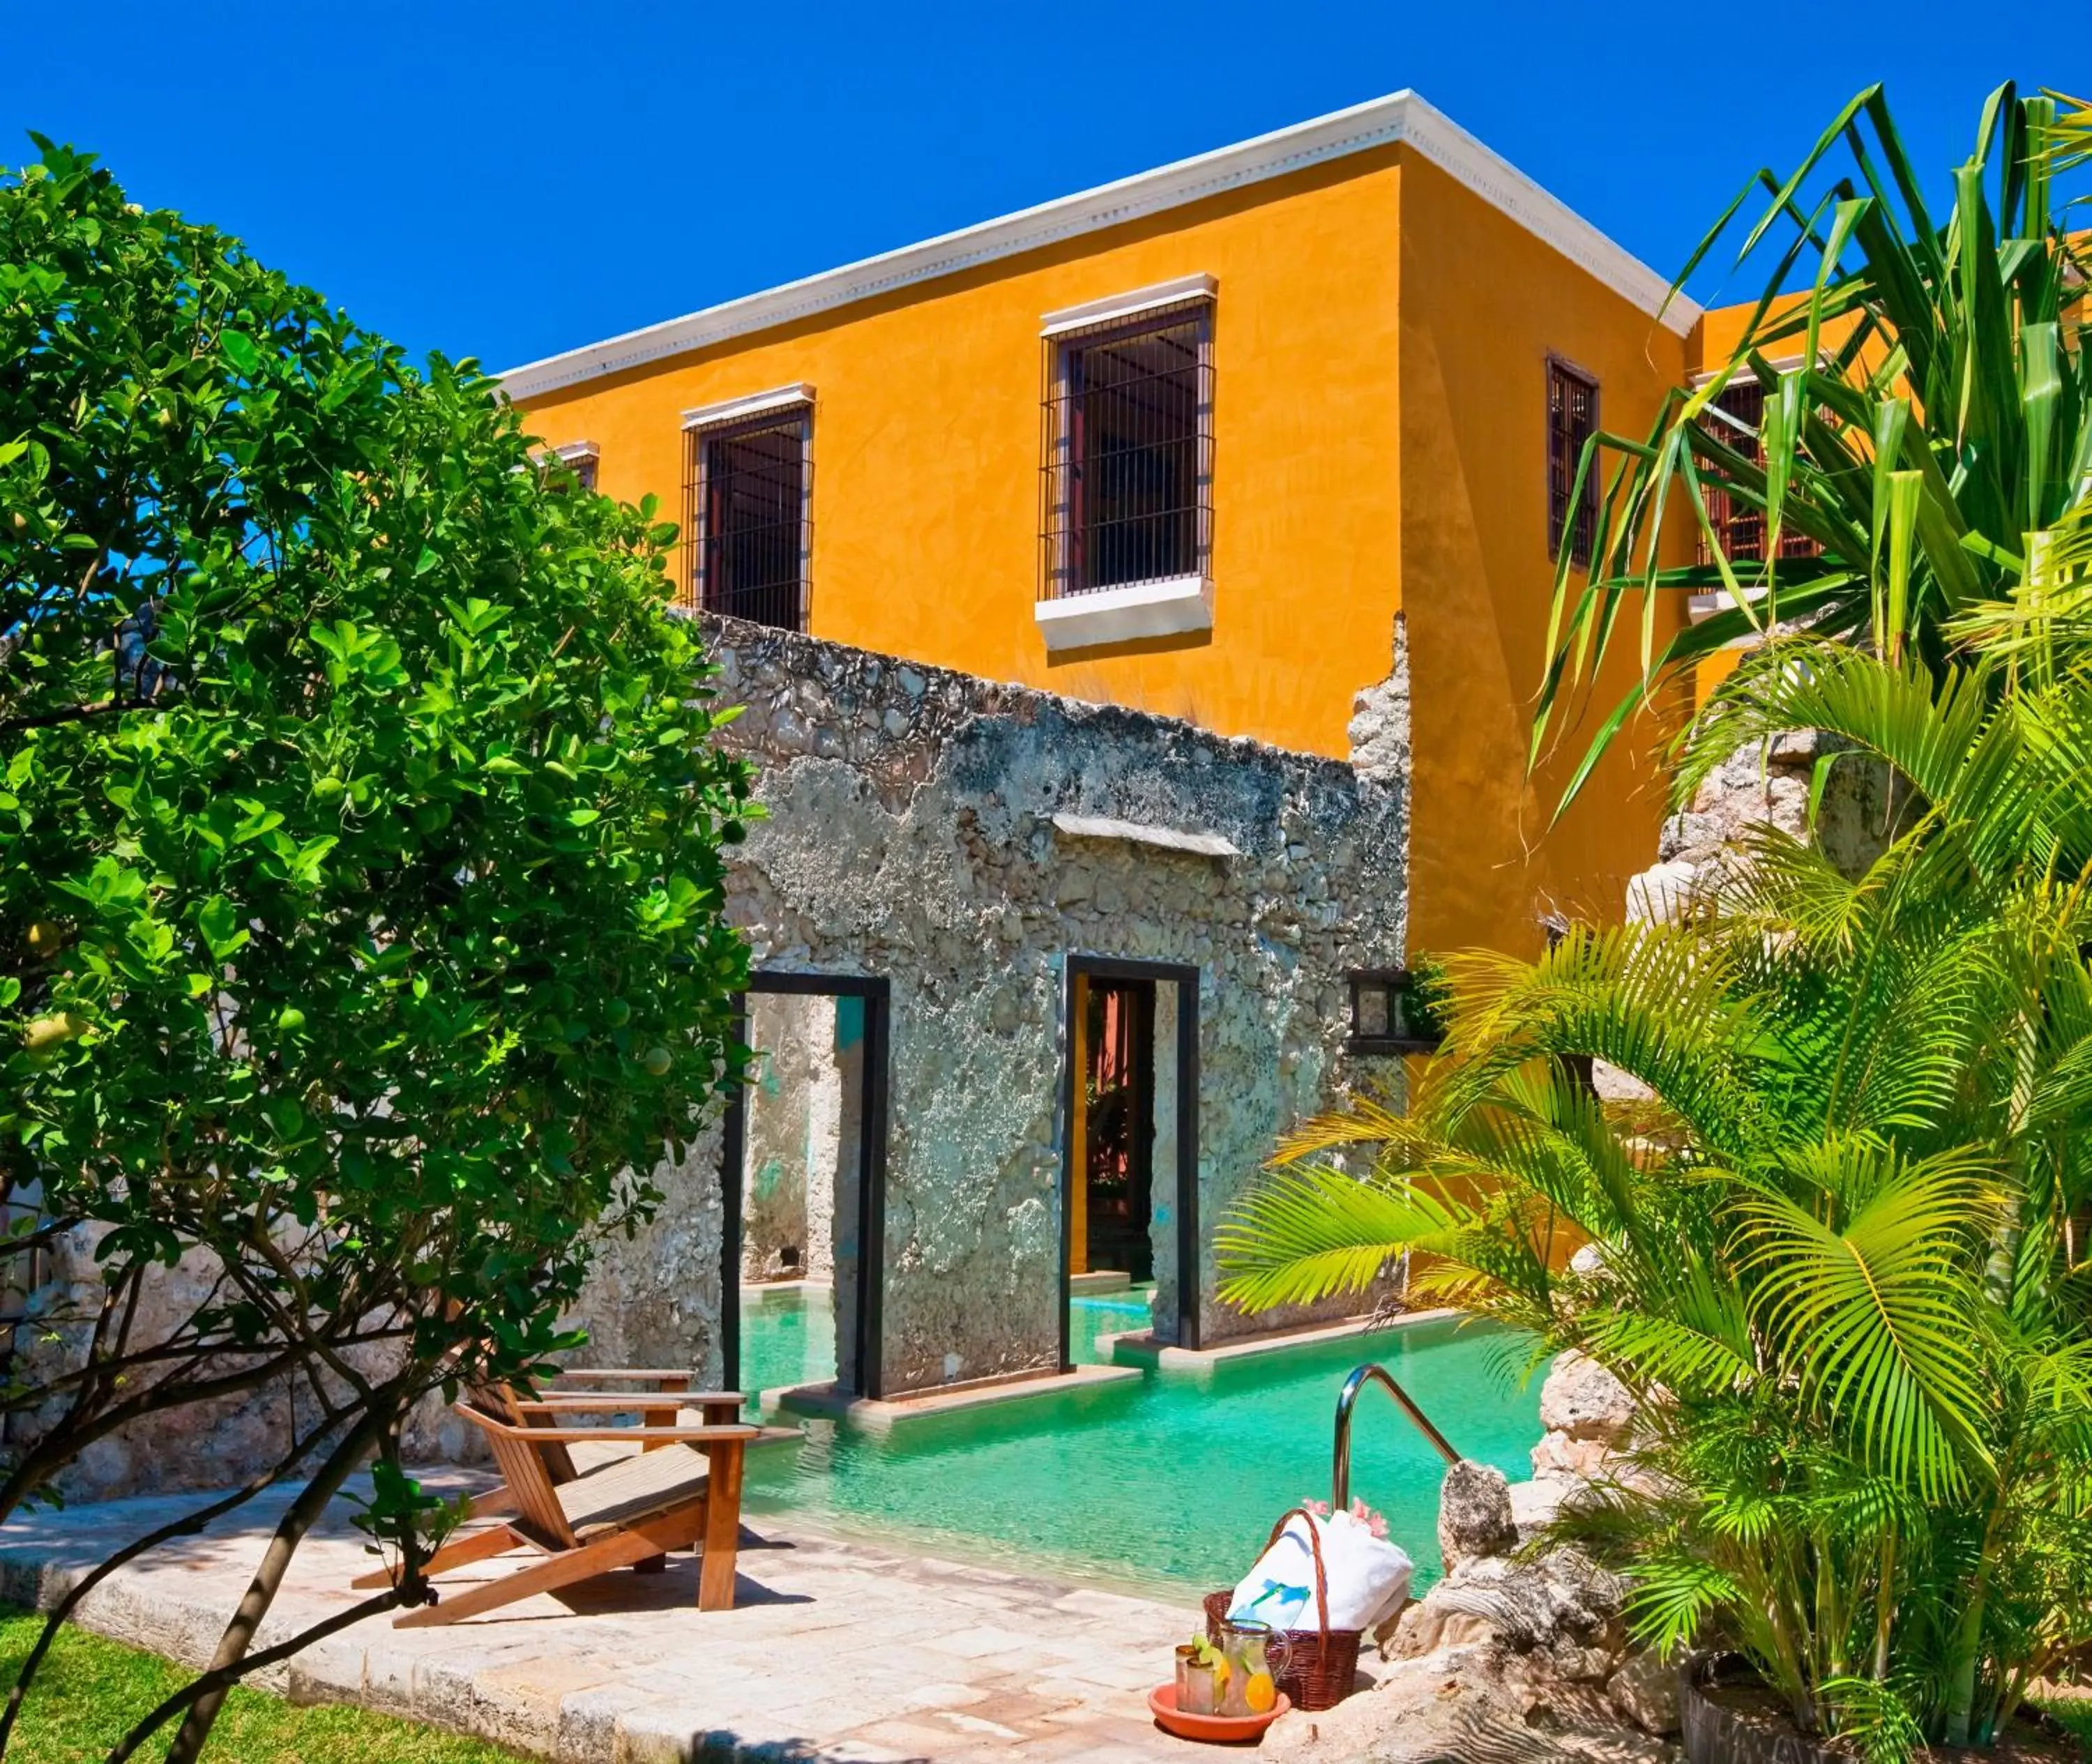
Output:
[{"xmin": 356, "ymin": 1392, "xmax": 761, "ymax": 1628}]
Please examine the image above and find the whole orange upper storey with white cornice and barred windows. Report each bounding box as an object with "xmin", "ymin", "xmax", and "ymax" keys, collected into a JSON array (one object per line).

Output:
[{"xmin": 504, "ymin": 92, "xmax": 1701, "ymax": 952}]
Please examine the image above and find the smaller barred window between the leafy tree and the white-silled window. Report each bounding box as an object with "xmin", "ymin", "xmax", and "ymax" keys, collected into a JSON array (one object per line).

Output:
[{"xmin": 684, "ymin": 406, "xmax": 814, "ymax": 630}]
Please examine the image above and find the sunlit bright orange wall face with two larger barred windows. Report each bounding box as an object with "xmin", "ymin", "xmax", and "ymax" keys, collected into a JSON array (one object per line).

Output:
[{"xmin": 513, "ymin": 151, "xmax": 1400, "ymax": 755}]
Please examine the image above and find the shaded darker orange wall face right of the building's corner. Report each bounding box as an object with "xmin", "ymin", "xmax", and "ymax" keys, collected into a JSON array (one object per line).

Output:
[{"xmin": 1400, "ymin": 159, "xmax": 1686, "ymax": 955}]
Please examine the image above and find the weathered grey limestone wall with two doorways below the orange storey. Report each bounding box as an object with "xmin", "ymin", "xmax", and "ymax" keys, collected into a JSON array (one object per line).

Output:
[{"xmin": 582, "ymin": 621, "xmax": 1408, "ymax": 1394}]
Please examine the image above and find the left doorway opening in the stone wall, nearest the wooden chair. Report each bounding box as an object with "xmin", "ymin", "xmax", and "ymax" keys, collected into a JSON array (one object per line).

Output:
[{"xmin": 720, "ymin": 973, "xmax": 887, "ymax": 1411}]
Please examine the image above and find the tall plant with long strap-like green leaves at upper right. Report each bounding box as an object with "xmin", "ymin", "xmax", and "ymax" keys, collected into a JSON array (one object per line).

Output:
[{"xmin": 1531, "ymin": 75, "xmax": 2092, "ymax": 805}]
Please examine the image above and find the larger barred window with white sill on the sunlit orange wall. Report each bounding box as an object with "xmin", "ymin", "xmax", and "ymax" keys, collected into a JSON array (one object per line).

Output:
[{"xmin": 1040, "ymin": 299, "xmax": 1213, "ymax": 600}]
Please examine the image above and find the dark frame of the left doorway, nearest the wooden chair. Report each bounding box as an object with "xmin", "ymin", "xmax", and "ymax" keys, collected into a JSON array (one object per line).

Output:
[{"xmin": 720, "ymin": 969, "xmax": 891, "ymax": 1398}]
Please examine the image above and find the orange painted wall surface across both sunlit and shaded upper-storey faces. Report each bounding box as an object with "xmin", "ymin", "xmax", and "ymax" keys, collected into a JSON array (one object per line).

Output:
[{"xmin": 515, "ymin": 149, "xmax": 1686, "ymax": 952}]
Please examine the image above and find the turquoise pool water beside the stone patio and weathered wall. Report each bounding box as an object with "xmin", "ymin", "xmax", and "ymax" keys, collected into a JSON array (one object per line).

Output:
[{"xmin": 743, "ymin": 1293, "xmax": 1540, "ymax": 1597}]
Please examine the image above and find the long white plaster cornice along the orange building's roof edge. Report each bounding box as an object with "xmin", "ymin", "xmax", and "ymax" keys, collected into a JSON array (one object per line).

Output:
[{"xmin": 500, "ymin": 92, "xmax": 1701, "ymax": 397}]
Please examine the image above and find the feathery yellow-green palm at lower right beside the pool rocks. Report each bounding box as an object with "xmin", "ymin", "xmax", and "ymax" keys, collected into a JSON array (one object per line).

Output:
[{"xmin": 1222, "ymin": 812, "xmax": 2092, "ymax": 1754}]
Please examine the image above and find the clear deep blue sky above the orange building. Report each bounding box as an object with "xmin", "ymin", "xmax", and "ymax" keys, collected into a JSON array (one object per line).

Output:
[{"xmin": 0, "ymin": 0, "xmax": 2092, "ymax": 368}]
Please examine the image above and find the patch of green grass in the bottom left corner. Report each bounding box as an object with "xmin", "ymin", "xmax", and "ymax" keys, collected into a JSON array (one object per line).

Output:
[{"xmin": 0, "ymin": 1605, "xmax": 531, "ymax": 1764}]
